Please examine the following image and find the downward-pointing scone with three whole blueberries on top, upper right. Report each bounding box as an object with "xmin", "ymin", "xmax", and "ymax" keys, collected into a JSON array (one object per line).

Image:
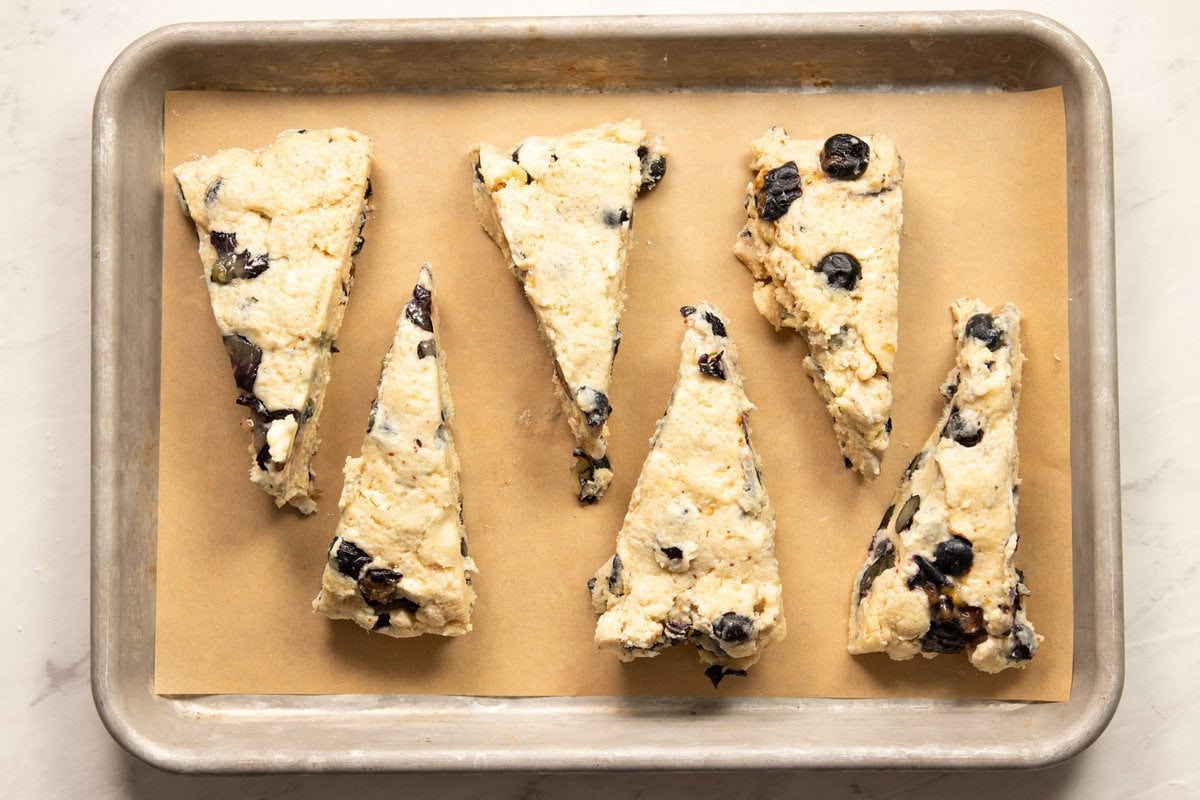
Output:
[{"xmin": 733, "ymin": 127, "xmax": 902, "ymax": 477}]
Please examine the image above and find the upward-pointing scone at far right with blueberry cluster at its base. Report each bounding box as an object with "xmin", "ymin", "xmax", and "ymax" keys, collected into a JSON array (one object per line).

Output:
[{"xmin": 850, "ymin": 299, "xmax": 1042, "ymax": 672}]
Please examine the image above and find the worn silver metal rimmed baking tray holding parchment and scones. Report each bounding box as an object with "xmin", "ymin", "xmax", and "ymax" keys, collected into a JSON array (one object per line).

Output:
[{"xmin": 91, "ymin": 12, "xmax": 1123, "ymax": 772}]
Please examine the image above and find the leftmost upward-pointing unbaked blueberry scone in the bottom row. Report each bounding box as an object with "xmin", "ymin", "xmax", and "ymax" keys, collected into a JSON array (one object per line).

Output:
[{"xmin": 313, "ymin": 265, "xmax": 475, "ymax": 637}]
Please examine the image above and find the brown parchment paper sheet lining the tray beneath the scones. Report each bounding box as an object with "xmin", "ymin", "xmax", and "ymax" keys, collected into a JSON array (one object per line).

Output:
[{"xmin": 155, "ymin": 90, "xmax": 1072, "ymax": 700}]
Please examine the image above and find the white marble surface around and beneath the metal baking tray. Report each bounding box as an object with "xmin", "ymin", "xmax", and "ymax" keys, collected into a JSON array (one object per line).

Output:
[{"xmin": 0, "ymin": 0, "xmax": 1200, "ymax": 800}]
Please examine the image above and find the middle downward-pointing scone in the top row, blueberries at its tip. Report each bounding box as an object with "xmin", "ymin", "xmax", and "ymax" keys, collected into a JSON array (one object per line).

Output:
[{"xmin": 472, "ymin": 120, "xmax": 666, "ymax": 503}]
